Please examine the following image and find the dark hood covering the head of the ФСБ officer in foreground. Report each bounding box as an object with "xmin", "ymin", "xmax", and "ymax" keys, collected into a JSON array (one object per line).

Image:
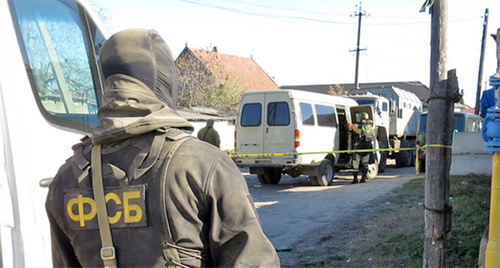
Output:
[{"xmin": 92, "ymin": 29, "xmax": 193, "ymax": 144}]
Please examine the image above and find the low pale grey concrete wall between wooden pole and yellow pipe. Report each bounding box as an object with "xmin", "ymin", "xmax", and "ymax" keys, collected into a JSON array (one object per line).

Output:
[{"xmin": 450, "ymin": 132, "xmax": 492, "ymax": 176}]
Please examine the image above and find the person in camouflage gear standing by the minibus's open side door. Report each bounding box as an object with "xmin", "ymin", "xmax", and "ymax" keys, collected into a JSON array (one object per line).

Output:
[{"xmin": 349, "ymin": 112, "xmax": 375, "ymax": 183}]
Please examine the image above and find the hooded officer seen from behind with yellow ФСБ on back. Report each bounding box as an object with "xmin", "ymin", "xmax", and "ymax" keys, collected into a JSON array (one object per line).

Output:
[{"xmin": 46, "ymin": 29, "xmax": 280, "ymax": 267}]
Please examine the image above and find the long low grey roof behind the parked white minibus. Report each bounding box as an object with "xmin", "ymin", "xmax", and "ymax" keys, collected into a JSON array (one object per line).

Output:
[{"xmin": 281, "ymin": 81, "xmax": 429, "ymax": 102}]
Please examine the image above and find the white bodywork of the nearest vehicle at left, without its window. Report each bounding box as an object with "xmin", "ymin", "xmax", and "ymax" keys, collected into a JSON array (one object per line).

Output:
[{"xmin": 0, "ymin": 1, "xmax": 105, "ymax": 267}]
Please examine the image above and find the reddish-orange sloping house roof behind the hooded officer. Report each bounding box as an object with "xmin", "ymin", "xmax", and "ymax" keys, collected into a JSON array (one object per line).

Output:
[{"xmin": 178, "ymin": 46, "xmax": 279, "ymax": 91}]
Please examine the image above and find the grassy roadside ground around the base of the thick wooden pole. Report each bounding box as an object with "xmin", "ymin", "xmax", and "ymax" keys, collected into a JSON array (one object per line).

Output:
[{"xmin": 299, "ymin": 176, "xmax": 491, "ymax": 267}]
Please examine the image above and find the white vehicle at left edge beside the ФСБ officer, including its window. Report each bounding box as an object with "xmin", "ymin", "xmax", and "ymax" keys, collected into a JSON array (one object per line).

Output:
[{"xmin": 0, "ymin": 0, "xmax": 105, "ymax": 267}]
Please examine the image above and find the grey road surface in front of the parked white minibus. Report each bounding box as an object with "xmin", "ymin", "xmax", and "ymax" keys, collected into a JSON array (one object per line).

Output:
[{"xmin": 243, "ymin": 161, "xmax": 423, "ymax": 267}]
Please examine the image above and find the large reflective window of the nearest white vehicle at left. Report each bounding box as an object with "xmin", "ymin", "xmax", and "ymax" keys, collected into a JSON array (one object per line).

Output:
[{"xmin": 11, "ymin": 0, "xmax": 103, "ymax": 132}]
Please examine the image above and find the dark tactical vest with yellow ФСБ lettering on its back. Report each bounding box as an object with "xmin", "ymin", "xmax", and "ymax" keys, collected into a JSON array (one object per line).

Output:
[{"xmin": 64, "ymin": 129, "xmax": 207, "ymax": 267}]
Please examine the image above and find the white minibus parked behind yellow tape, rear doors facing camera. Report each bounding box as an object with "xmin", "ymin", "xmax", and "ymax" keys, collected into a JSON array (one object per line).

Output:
[{"xmin": 234, "ymin": 90, "xmax": 376, "ymax": 186}]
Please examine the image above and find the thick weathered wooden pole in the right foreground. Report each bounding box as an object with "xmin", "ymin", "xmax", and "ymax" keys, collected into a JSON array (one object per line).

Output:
[{"xmin": 423, "ymin": 0, "xmax": 453, "ymax": 267}]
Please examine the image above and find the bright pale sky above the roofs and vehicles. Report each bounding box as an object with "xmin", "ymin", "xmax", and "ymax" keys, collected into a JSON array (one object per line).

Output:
[{"xmin": 91, "ymin": 0, "xmax": 500, "ymax": 106}]
